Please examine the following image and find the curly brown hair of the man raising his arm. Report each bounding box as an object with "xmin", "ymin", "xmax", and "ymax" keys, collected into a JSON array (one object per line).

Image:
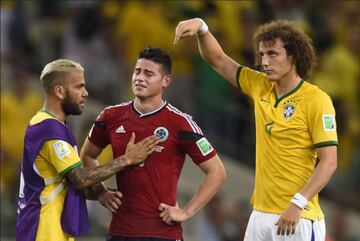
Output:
[{"xmin": 254, "ymin": 20, "xmax": 317, "ymax": 79}]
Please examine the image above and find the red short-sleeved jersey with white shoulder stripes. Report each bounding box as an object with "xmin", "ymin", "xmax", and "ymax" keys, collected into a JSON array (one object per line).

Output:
[{"xmin": 89, "ymin": 101, "xmax": 216, "ymax": 239}]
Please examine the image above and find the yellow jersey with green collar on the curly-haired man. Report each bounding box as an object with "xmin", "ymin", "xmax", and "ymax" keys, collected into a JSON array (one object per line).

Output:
[{"xmin": 237, "ymin": 67, "xmax": 338, "ymax": 220}]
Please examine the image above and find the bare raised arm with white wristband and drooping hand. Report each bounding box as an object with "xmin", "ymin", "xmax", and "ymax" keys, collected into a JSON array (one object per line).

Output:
[{"xmin": 174, "ymin": 18, "xmax": 240, "ymax": 86}]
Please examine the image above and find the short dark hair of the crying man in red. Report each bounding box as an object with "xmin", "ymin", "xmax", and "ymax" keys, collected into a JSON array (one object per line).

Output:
[{"xmin": 138, "ymin": 47, "xmax": 172, "ymax": 74}]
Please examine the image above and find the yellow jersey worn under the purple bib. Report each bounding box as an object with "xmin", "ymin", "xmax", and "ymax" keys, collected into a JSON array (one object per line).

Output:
[{"xmin": 30, "ymin": 111, "xmax": 82, "ymax": 241}]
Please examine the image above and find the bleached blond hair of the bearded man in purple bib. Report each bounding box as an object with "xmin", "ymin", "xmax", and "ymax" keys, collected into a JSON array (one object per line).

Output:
[{"xmin": 40, "ymin": 59, "xmax": 84, "ymax": 93}]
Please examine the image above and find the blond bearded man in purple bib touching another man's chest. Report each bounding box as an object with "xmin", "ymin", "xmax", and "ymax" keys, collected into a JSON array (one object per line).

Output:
[{"xmin": 16, "ymin": 59, "xmax": 158, "ymax": 241}]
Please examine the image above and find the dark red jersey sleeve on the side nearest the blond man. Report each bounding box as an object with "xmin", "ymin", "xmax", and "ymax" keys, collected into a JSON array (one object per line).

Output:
[{"xmin": 88, "ymin": 110, "xmax": 109, "ymax": 149}]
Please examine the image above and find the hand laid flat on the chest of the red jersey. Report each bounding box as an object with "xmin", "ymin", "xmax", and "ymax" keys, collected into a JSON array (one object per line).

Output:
[{"xmin": 125, "ymin": 132, "xmax": 160, "ymax": 165}]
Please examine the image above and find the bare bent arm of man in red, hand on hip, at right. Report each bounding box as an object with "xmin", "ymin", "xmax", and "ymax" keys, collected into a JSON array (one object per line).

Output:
[{"xmin": 159, "ymin": 155, "xmax": 226, "ymax": 224}]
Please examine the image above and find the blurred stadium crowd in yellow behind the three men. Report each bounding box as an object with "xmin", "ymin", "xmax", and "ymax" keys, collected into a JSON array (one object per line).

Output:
[{"xmin": 0, "ymin": 0, "xmax": 360, "ymax": 241}]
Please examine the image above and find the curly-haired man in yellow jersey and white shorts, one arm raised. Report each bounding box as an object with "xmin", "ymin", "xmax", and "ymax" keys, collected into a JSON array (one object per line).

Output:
[{"xmin": 174, "ymin": 18, "xmax": 338, "ymax": 241}]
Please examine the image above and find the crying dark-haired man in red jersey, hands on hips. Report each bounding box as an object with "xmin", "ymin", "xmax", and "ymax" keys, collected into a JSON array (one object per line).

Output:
[{"xmin": 81, "ymin": 48, "xmax": 226, "ymax": 241}]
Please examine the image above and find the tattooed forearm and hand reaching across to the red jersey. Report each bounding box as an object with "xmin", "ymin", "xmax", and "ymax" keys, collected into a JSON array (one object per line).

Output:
[{"xmin": 66, "ymin": 133, "xmax": 159, "ymax": 189}]
